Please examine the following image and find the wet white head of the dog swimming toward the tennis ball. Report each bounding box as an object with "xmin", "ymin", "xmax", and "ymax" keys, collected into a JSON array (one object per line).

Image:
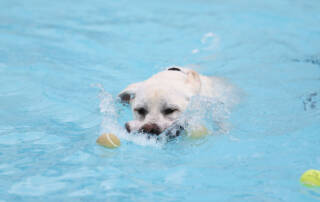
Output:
[{"xmin": 119, "ymin": 67, "xmax": 201, "ymax": 135}]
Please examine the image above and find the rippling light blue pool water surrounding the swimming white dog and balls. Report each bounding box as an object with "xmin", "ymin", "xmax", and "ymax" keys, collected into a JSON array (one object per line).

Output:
[{"xmin": 0, "ymin": 0, "xmax": 320, "ymax": 202}]
